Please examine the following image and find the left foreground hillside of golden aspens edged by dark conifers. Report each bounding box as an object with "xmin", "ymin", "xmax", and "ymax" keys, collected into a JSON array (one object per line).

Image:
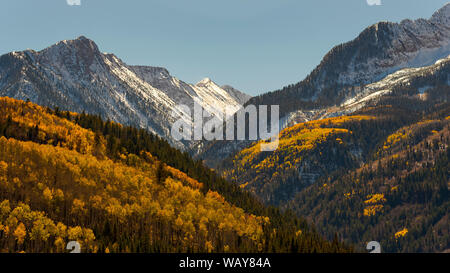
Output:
[{"xmin": 0, "ymin": 98, "xmax": 349, "ymax": 252}]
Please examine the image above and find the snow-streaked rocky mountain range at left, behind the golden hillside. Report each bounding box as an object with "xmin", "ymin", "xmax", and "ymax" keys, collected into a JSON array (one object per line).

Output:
[{"xmin": 0, "ymin": 36, "xmax": 250, "ymax": 148}]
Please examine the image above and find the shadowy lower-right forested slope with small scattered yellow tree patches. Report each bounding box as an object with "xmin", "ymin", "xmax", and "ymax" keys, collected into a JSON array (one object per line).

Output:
[{"xmin": 289, "ymin": 112, "xmax": 450, "ymax": 252}]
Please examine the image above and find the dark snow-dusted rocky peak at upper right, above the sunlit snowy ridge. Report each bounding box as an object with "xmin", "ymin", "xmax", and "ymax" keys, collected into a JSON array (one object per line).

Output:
[{"xmin": 249, "ymin": 3, "xmax": 450, "ymax": 116}]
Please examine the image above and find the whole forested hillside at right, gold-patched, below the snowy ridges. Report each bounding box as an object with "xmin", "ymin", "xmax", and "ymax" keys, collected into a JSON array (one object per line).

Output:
[{"xmin": 222, "ymin": 90, "xmax": 450, "ymax": 252}]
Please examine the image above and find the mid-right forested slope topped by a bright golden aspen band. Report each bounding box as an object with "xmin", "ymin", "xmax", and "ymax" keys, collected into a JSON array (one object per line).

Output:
[{"xmin": 222, "ymin": 109, "xmax": 412, "ymax": 205}]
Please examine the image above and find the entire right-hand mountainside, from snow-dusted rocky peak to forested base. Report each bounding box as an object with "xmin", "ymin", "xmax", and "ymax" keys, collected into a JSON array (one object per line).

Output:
[{"xmin": 212, "ymin": 4, "xmax": 450, "ymax": 248}]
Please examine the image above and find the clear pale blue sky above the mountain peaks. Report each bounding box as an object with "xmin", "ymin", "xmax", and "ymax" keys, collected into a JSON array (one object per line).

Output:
[{"xmin": 0, "ymin": 0, "xmax": 447, "ymax": 95}]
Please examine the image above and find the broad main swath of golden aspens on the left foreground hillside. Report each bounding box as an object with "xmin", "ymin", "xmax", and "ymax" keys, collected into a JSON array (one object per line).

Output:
[{"xmin": 0, "ymin": 137, "xmax": 268, "ymax": 252}]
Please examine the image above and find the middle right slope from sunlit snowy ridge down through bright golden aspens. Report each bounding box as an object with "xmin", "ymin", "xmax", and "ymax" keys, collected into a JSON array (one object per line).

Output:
[{"xmin": 221, "ymin": 46, "xmax": 450, "ymax": 204}]
